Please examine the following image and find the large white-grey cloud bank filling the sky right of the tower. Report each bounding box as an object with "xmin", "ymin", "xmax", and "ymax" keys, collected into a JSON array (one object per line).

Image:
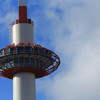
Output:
[{"xmin": 35, "ymin": 0, "xmax": 100, "ymax": 100}]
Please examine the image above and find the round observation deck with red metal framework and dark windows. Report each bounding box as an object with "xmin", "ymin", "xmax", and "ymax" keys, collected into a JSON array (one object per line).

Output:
[{"xmin": 0, "ymin": 43, "xmax": 60, "ymax": 79}]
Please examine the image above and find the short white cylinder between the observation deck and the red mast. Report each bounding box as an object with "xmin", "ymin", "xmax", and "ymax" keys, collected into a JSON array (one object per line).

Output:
[{"xmin": 11, "ymin": 23, "xmax": 34, "ymax": 45}]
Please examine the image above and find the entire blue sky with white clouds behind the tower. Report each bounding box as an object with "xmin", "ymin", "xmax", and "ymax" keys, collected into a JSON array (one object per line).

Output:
[{"xmin": 0, "ymin": 0, "xmax": 100, "ymax": 100}]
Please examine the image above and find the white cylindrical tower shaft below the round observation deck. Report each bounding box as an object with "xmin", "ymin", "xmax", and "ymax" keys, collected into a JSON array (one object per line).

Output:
[{"xmin": 13, "ymin": 72, "xmax": 36, "ymax": 100}]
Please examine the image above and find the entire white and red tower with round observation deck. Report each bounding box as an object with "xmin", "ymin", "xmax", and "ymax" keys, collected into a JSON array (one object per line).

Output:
[{"xmin": 0, "ymin": 0, "xmax": 60, "ymax": 100}]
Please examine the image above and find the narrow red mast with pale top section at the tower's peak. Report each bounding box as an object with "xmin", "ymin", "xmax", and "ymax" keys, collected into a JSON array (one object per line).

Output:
[{"xmin": 18, "ymin": 0, "xmax": 27, "ymax": 20}]
